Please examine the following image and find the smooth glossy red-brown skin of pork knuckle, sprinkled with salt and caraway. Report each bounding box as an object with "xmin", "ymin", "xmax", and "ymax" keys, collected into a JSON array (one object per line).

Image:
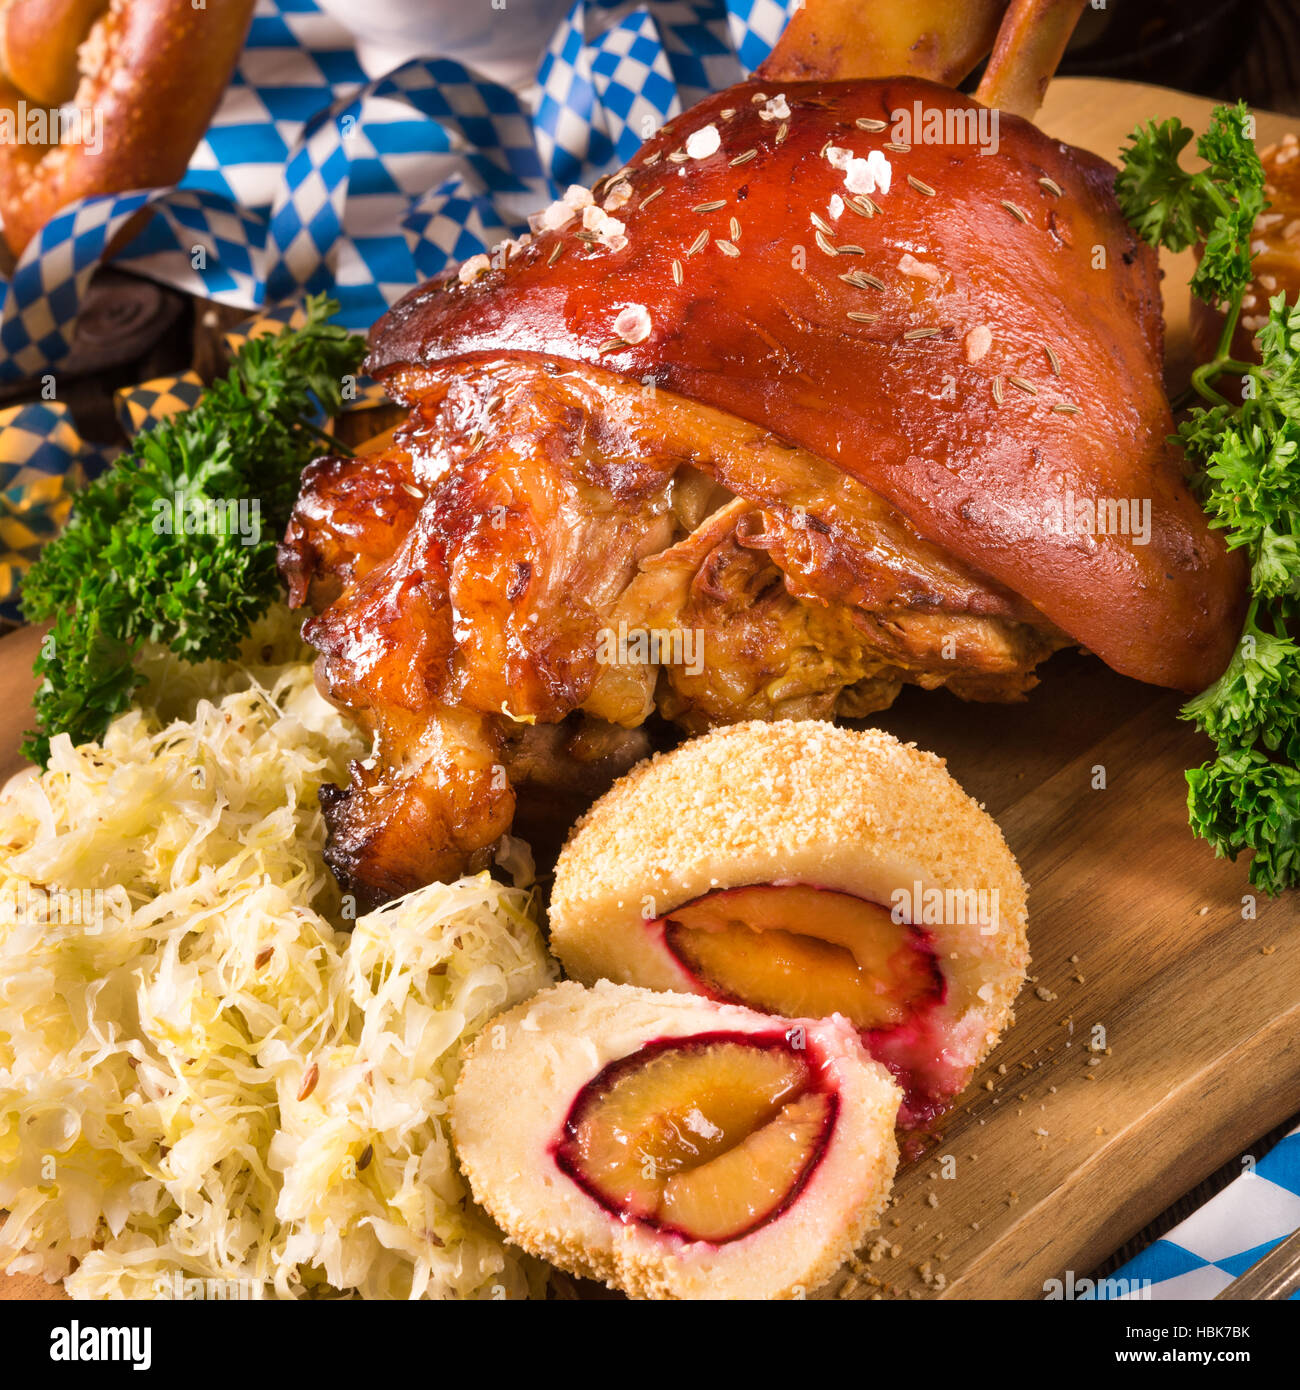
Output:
[{"xmin": 370, "ymin": 78, "xmax": 1244, "ymax": 689}]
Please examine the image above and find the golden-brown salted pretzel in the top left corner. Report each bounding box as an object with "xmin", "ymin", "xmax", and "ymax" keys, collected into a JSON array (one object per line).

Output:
[{"xmin": 0, "ymin": 0, "xmax": 253, "ymax": 256}]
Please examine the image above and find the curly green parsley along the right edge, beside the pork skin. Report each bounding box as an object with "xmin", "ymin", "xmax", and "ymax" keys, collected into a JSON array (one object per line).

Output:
[{"xmin": 1115, "ymin": 103, "xmax": 1300, "ymax": 894}]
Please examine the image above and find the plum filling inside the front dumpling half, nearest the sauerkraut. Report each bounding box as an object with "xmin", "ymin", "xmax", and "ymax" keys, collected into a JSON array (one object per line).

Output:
[{"xmin": 555, "ymin": 1033, "xmax": 838, "ymax": 1245}]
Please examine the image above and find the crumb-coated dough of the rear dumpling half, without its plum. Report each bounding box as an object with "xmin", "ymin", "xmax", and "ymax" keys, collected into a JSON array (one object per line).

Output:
[{"xmin": 551, "ymin": 720, "xmax": 1029, "ymax": 1087}]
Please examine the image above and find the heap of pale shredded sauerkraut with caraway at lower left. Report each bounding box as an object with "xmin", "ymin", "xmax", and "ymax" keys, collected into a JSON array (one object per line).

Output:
[{"xmin": 0, "ymin": 613, "xmax": 555, "ymax": 1298}]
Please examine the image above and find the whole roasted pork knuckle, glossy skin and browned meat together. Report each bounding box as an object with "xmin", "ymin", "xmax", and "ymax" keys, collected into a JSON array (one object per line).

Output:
[{"xmin": 281, "ymin": 78, "xmax": 1244, "ymax": 901}]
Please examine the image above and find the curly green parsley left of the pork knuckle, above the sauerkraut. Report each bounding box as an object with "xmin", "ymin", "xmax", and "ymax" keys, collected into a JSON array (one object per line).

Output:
[{"xmin": 22, "ymin": 296, "xmax": 364, "ymax": 766}]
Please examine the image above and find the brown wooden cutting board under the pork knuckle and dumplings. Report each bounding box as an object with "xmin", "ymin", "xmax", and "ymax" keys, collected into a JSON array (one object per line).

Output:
[{"xmin": 0, "ymin": 79, "xmax": 1300, "ymax": 1298}]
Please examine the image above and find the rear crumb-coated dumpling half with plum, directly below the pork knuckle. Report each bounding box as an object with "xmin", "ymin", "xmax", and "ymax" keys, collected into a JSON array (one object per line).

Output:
[{"xmin": 551, "ymin": 720, "xmax": 1027, "ymax": 1127}]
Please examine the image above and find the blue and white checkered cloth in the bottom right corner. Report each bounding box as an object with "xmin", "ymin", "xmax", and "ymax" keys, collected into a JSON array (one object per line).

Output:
[{"xmin": 1097, "ymin": 1129, "xmax": 1300, "ymax": 1301}]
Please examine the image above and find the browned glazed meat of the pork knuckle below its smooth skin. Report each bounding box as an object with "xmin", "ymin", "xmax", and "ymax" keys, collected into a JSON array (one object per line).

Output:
[{"xmin": 289, "ymin": 357, "xmax": 1066, "ymax": 904}]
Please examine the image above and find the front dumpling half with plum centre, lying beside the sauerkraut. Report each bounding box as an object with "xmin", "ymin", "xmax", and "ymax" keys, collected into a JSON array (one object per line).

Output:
[{"xmin": 452, "ymin": 981, "xmax": 900, "ymax": 1298}]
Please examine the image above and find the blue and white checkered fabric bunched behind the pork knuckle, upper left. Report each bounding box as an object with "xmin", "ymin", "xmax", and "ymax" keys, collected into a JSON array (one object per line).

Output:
[{"xmin": 0, "ymin": 0, "xmax": 797, "ymax": 381}]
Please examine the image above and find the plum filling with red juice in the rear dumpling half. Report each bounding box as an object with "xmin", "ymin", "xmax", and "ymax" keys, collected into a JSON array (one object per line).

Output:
[{"xmin": 653, "ymin": 883, "xmax": 945, "ymax": 1126}]
